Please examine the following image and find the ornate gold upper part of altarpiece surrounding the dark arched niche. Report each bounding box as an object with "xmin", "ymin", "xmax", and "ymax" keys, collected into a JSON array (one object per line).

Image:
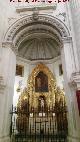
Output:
[{"xmin": 18, "ymin": 63, "xmax": 65, "ymax": 109}]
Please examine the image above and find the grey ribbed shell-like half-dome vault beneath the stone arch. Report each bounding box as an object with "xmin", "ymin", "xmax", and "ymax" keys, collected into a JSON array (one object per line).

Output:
[{"xmin": 18, "ymin": 37, "xmax": 60, "ymax": 60}]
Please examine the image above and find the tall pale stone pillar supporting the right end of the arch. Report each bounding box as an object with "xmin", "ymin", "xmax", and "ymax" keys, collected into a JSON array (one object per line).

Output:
[{"xmin": 61, "ymin": 38, "xmax": 80, "ymax": 142}]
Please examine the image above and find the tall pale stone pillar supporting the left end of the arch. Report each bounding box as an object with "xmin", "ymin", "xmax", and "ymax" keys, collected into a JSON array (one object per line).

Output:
[{"xmin": 0, "ymin": 42, "xmax": 16, "ymax": 142}]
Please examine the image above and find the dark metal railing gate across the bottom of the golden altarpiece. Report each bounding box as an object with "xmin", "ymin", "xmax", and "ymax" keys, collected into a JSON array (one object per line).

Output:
[{"xmin": 10, "ymin": 100, "xmax": 68, "ymax": 142}]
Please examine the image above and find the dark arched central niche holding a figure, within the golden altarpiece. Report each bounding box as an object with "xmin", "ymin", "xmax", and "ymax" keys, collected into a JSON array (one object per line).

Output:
[{"xmin": 35, "ymin": 72, "xmax": 48, "ymax": 92}]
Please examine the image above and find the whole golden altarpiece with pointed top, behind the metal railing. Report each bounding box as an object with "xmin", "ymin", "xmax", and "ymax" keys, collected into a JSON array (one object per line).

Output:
[{"xmin": 16, "ymin": 63, "xmax": 67, "ymax": 132}]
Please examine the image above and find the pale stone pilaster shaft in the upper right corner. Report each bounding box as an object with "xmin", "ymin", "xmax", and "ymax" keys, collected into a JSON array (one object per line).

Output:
[{"xmin": 69, "ymin": 0, "xmax": 80, "ymax": 69}]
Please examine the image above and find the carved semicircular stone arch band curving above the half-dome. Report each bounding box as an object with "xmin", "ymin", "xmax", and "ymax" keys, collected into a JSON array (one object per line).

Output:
[{"xmin": 4, "ymin": 14, "xmax": 70, "ymax": 43}]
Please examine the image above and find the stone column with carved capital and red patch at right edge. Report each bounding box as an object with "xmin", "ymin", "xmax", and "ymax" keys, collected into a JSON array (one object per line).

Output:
[{"xmin": 69, "ymin": 72, "xmax": 80, "ymax": 142}]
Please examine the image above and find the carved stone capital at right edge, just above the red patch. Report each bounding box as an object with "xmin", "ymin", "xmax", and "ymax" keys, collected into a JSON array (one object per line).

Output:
[{"xmin": 71, "ymin": 72, "xmax": 80, "ymax": 90}]
